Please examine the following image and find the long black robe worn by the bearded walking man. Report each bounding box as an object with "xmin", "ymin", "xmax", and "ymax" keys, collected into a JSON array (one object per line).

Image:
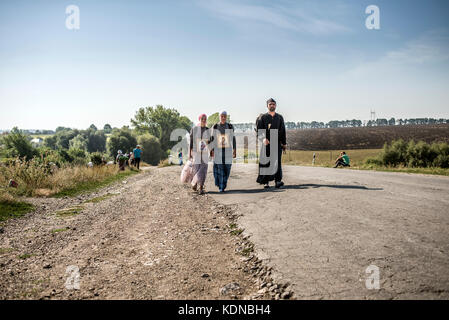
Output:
[{"xmin": 256, "ymin": 113, "xmax": 287, "ymax": 184}]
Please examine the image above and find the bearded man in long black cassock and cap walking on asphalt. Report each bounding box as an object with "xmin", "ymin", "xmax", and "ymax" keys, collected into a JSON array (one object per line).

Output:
[{"xmin": 256, "ymin": 98, "xmax": 287, "ymax": 188}]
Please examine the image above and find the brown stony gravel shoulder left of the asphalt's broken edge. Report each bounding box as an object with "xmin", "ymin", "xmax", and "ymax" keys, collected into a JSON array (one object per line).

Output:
[{"xmin": 0, "ymin": 167, "xmax": 289, "ymax": 299}]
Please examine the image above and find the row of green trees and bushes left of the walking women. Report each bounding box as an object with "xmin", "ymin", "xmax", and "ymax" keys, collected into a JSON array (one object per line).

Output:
[{"xmin": 0, "ymin": 105, "xmax": 193, "ymax": 165}]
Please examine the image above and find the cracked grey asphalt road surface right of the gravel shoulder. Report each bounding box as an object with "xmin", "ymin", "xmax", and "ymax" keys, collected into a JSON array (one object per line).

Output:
[{"xmin": 209, "ymin": 165, "xmax": 449, "ymax": 299}]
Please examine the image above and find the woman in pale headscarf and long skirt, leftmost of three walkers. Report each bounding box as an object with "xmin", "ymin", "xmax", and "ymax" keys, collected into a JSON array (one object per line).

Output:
[{"xmin": 189, "ymin": 113, "xmax": 210, "ymax": 194}]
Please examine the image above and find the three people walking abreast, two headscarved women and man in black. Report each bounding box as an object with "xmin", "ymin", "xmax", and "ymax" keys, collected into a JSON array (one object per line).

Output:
[{"xmin": 186, "ymin": 98, "xmax": 287, "ymax": 194}]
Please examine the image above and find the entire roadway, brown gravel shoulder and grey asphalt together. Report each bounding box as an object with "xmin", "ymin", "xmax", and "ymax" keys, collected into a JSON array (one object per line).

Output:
[{"xmin": 0, "ymin": 165, "xmax": 449, "ymax": 299}]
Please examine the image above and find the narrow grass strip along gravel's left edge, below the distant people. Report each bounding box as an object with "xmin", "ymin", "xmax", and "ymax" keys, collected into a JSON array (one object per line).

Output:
[{"xmin": 53, "ymin": 168, "xmax": 140, "ymax": 198}]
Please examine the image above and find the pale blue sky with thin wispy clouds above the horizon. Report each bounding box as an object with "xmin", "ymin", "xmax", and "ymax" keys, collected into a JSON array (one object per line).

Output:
[{"xmin": 0, "ymin": 0, "xmax": 449, "ymax": 129}]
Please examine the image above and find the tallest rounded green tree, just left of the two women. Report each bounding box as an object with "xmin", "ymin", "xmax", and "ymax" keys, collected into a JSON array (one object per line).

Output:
[{"xmin": 131, "ymin": 105, "xmax": 192, "ymax": 151}]
